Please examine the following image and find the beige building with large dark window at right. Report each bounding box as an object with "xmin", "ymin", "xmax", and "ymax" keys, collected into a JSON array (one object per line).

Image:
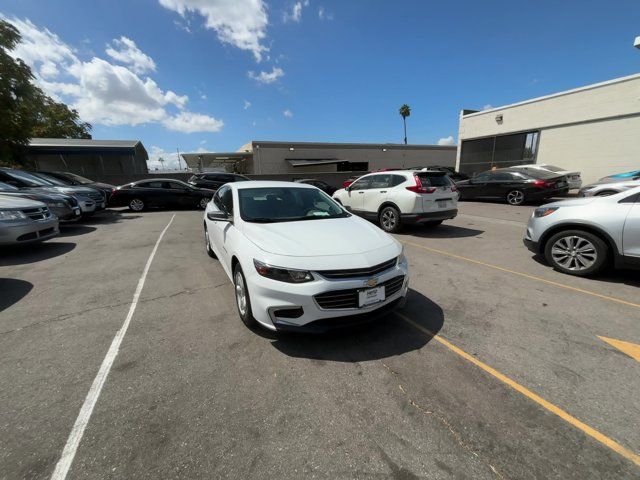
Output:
[{"xmin": 456, "ymin": 74, "xmax": 640, "ymax": 183}]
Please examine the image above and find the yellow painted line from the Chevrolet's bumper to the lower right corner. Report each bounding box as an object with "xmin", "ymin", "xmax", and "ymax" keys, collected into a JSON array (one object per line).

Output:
[{"xmin": 396, "ymin": 312, "xmax": 640, "ymax": 467}]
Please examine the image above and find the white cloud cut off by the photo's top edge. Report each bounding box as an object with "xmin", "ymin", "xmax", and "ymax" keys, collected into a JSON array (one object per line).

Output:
[{"xmin": 159, "ymin": 0, "xmax": 269, "ymax": 62}]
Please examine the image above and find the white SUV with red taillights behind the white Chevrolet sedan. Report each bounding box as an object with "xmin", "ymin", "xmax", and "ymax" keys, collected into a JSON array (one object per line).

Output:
[{"xmin": 333, "ymin": 170, "xmax": 458, "ymax": 232}]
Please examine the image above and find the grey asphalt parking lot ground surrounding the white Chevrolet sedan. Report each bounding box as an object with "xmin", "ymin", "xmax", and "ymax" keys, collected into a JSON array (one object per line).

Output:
[{"xmin": 0, "ymin": 202, "xmax": 640, "ymax": 479}]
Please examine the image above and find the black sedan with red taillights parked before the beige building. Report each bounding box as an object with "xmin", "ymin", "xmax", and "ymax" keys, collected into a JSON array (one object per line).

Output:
[{"xmin": 456, "ymin": 168, "xmax": 569, "ymax": 205}]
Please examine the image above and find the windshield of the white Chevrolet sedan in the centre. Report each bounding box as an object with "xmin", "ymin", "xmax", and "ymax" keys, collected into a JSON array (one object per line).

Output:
[{"xmin": 238, "ymin": 187, "xmax": 350, "ymax": 223}]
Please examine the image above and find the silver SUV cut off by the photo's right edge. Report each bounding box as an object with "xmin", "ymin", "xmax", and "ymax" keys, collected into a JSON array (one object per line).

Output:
[{"xmin": 523, "ymin": 187, "xmax": 640, "ymax": 276}]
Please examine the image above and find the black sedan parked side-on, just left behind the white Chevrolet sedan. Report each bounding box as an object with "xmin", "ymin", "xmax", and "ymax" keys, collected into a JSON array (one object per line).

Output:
[{"xmin": 109, "ymin": 178, "xmax": 215, "ymax": 212}]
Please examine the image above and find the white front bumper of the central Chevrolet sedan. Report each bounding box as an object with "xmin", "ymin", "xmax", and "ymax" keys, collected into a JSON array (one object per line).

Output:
[{"xmin": 243, "ymin": 262, "xmax": 409, "ymax": 332}]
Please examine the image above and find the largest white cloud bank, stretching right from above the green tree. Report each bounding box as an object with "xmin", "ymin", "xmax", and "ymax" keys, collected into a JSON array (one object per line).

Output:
[{"xmin": 3, "ymin": 17, "xmax": 223, "ymax": 133}]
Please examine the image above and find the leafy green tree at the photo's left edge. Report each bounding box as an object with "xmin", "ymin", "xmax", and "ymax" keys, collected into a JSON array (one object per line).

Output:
[{"xmin": 0, "ymin": 20, "xmax": 91, "ymax": 165}]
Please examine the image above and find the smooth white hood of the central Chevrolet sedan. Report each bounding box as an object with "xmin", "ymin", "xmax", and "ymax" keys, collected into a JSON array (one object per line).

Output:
[{"xmin": 243, "ymin": 216, "xmax": 397, "ymax": 257}]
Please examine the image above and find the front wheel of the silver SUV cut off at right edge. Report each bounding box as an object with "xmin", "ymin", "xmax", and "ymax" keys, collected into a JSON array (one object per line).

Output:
[{"xmin": 544, "ymin": 230, "xmax": 609, "ymax": 277}]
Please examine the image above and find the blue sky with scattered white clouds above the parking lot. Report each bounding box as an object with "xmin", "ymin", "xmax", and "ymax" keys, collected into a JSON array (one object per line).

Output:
[{"xmin": 0, "ymin": 0, "xmax": 640, "ymax": 169}]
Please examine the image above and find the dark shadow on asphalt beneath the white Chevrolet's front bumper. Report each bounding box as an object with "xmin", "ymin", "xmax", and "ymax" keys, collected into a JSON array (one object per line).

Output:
[{"xmin": 268, "ymin": 290, "xmax": 444, "ymax": 362}]
